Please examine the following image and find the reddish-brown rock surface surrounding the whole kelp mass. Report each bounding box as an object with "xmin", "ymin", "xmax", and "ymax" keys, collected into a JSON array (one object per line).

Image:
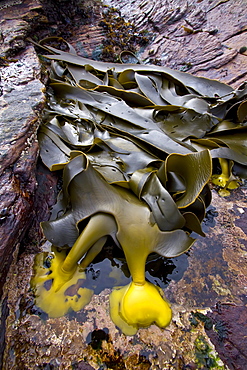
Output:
[{"xmin": 0, "ymin": 0, "xmax": 247, "ymax": 370}]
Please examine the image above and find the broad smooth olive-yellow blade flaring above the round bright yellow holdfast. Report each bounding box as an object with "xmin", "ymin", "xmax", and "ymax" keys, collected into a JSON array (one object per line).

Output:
[{"xmin": 42, "ymin": 153, "xmax": 197, "ymax": 262}]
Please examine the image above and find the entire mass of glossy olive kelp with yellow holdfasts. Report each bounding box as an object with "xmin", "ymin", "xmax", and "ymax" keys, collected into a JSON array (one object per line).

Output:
[{"xmin": 33, "ymin": 40, "xmax": 247, "ymax": 335}]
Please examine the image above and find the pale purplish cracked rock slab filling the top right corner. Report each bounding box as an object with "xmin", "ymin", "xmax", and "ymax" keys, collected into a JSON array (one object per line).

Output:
[{"xmin": 105, "ymin": 0, "xmax": 247, "ymax": 86}]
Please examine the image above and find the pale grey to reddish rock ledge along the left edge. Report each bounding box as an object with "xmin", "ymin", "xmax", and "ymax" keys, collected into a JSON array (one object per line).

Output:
[{"xmin": 0, "ymin": 4, "xmax": 45, "ymax": 295}]
